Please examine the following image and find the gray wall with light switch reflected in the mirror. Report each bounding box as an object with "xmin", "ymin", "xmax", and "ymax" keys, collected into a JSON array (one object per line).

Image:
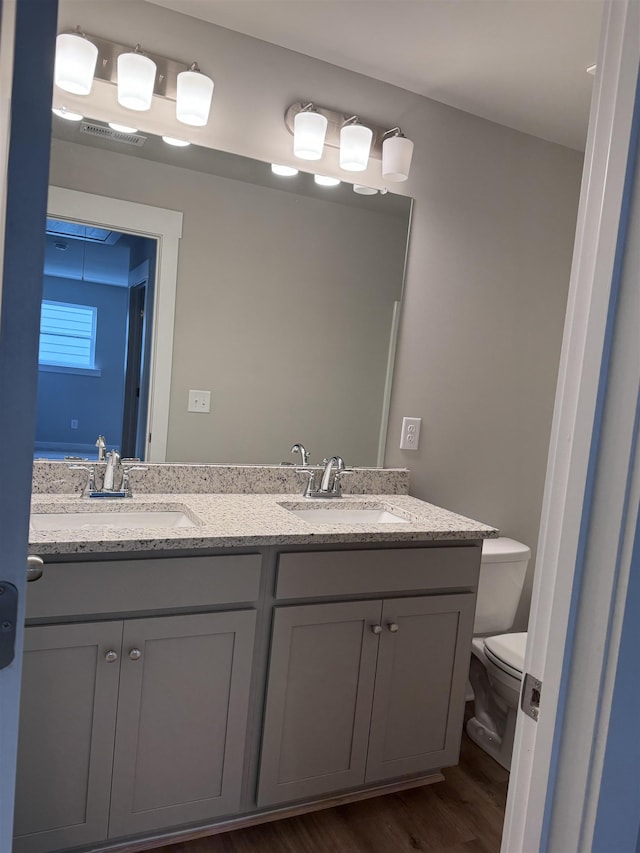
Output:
[{"xmin": 51, "ymin": 145, "xmax": 406, "ymax": 465}]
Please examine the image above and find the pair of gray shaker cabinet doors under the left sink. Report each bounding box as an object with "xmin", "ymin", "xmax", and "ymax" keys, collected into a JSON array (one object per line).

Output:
[{"xmin": 14, "ymin": 610, "xmax": 256, "ymax": 853}]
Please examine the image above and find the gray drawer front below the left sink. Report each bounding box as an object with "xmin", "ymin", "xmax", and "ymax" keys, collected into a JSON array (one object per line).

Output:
[{"xmin": 26, "ymin": 554, "xmax": 261, "ymax": 619}]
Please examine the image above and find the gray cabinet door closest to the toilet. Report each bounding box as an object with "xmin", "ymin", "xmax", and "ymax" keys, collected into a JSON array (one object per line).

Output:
[{"xmin": 366, "ymin": 594, "xmax": 475, "ymax": 782}]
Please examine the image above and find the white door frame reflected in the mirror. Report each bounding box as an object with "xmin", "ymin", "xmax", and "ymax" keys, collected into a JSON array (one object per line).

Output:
[{"xmin": 47, "ymin": 186, "xmax": 183, "ymax": 462}]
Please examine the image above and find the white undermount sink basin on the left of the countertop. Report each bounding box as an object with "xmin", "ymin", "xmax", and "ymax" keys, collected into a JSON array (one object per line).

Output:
[{"xmin": 29, "ymin": 509, "xmax": 196, "ymax": 530}]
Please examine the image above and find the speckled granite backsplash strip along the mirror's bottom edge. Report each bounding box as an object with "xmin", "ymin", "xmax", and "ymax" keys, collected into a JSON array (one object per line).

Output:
[{"xmin": 33, "ymin": 461, "xmax": 409, "ymax": 495}]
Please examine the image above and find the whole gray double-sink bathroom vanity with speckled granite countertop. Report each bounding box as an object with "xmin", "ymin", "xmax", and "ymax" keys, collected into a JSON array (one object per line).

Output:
[{"xmin": 14, "ymin": 470, "xmax": 497, "ymax": 853}]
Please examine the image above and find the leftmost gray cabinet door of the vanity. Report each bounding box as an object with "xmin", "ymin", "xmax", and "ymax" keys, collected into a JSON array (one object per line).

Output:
[{"xmin": 13, "ymin": 622, "xmax": 122, "ymax": 853}]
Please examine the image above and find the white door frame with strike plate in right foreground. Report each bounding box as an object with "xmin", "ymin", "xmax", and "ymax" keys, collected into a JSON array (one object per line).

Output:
[{"xmin": 502, "ymin": 0, "xmax": 640, "ymax": 853}]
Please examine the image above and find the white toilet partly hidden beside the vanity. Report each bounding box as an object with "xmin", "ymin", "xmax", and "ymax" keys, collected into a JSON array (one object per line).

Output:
[{"xmin": 467, "ymin": 537, "xmax": 531, "ymax": 770}]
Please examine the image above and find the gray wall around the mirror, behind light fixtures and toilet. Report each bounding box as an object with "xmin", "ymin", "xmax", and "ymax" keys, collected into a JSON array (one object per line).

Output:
[{"xmin": 61, "ymin": 0, "xmax": 582, "ymax": 624}]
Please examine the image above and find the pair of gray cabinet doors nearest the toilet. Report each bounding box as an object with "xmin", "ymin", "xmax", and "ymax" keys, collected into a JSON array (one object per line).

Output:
[{"xmin": 258, "ymin": 593, "xmax": 475, "ymax": 807}]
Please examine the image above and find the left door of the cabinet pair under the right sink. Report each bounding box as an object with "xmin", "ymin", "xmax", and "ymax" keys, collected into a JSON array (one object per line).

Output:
[{"xmin": 258, "ymin": 601, "xmax": 381, "ymax": 807}]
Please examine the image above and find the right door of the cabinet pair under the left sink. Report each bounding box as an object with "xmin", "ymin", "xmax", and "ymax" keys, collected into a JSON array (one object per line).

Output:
[{"xmin": 109, "ymin": 610, "xmax": 255, "ymax": 838}]
